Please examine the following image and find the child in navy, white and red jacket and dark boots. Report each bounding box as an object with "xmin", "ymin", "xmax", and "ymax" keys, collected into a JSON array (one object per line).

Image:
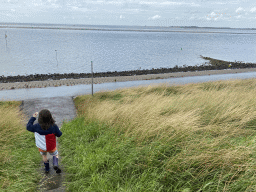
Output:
[{"xmin": 27, "ymin": 109, "xmax": 62, "ymax": 173}]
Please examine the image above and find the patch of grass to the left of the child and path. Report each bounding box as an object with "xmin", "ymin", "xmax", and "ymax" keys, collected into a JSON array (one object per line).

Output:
[{"xmin": 0, "ymin": 101, "xmax": 41, "ymax": 192}]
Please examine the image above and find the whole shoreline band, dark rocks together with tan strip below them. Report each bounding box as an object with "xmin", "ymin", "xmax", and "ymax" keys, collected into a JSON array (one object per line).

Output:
[{"xmin": 0, "ymin": 55, "xmax": 256, "ymax": 91}]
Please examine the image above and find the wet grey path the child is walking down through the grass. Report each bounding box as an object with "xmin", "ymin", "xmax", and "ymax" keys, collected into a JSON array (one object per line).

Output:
[{"xmin": 20, "ymin": 97, "xmax": 76, "ymax": 192}]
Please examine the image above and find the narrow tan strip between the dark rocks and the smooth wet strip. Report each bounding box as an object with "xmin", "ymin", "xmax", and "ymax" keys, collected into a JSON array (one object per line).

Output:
[{"xmin": 0, "ymin": 68, "xmax": 256, "ymax": 90}]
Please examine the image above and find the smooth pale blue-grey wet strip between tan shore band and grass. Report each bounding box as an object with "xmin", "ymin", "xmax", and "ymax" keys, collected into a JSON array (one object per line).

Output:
[{"xmin": 0, "ymin": 72, "xmax": 256, "ymax": 101}]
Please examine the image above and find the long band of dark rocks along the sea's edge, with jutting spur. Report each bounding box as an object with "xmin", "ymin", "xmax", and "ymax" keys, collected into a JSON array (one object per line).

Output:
[{"xmin": 0, "ymin": 56, "xmax": 256, "ymax": 83}]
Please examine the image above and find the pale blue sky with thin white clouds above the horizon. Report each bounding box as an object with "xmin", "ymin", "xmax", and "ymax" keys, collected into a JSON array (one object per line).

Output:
[{"xmin": 0, "ymin": 0, "xmax": 256, "ymax": 28}]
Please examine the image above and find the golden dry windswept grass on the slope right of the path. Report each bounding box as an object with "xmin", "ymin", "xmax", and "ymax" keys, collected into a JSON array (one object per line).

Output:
[{"xmin": 72, "ymin": 79, "xmax": 256, "ymax": 190}]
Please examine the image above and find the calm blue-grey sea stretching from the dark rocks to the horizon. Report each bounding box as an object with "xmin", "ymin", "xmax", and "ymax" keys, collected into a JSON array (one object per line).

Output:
[{"xmin": 0, "ymin": 25, "xmax": 256, "ymax": 76}]
